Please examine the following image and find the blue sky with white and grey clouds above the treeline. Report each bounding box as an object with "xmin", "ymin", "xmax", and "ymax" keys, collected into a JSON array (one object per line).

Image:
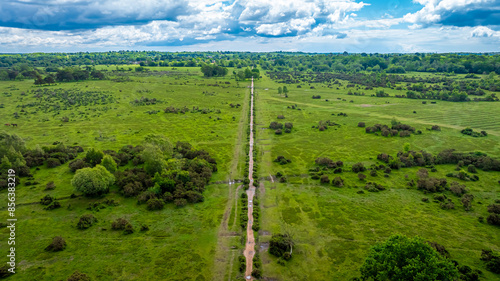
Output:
[{"xmin": 0, "ymin": 0, "xmax": 500, "ymax": 53}]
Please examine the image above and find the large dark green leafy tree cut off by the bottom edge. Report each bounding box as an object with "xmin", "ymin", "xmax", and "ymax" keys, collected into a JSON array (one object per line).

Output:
[{"xmin": 360, "ymin": 235, "xmax": 458, "ymax": 281}]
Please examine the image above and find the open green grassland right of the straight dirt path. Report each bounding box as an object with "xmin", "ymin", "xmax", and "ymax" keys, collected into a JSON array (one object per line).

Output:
[{"xmin": 256, "ymin": 71, "xmax": 500, "ymax": 280}]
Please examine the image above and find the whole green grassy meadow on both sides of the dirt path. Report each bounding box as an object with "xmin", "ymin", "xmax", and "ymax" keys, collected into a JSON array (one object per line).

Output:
[{"xmin": 0, "ymin": 61, "xmax": 500, "ymax": 281}]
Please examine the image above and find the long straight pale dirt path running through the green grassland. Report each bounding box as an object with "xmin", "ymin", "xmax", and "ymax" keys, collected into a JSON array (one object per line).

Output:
[{"xmin": 243, "ymin": 78, "xmax": 255, "ymax": 280}]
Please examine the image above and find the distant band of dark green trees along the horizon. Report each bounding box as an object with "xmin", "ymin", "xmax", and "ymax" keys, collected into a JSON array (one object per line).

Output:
[{"xmin": 0, "ymin": 51, "xmax": 500, "ymax": 80}]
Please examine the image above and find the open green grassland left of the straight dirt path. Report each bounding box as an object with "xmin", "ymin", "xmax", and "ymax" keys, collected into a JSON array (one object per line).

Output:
[{"xmin": 0, "ymin": 68, "xmax": 247, "ymax": 280}]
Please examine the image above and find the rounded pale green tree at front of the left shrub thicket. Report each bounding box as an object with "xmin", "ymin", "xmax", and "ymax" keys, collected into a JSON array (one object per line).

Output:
[{"xmin": 71, "ymin": 165, "xmax": 115, "ymax": 196}]
